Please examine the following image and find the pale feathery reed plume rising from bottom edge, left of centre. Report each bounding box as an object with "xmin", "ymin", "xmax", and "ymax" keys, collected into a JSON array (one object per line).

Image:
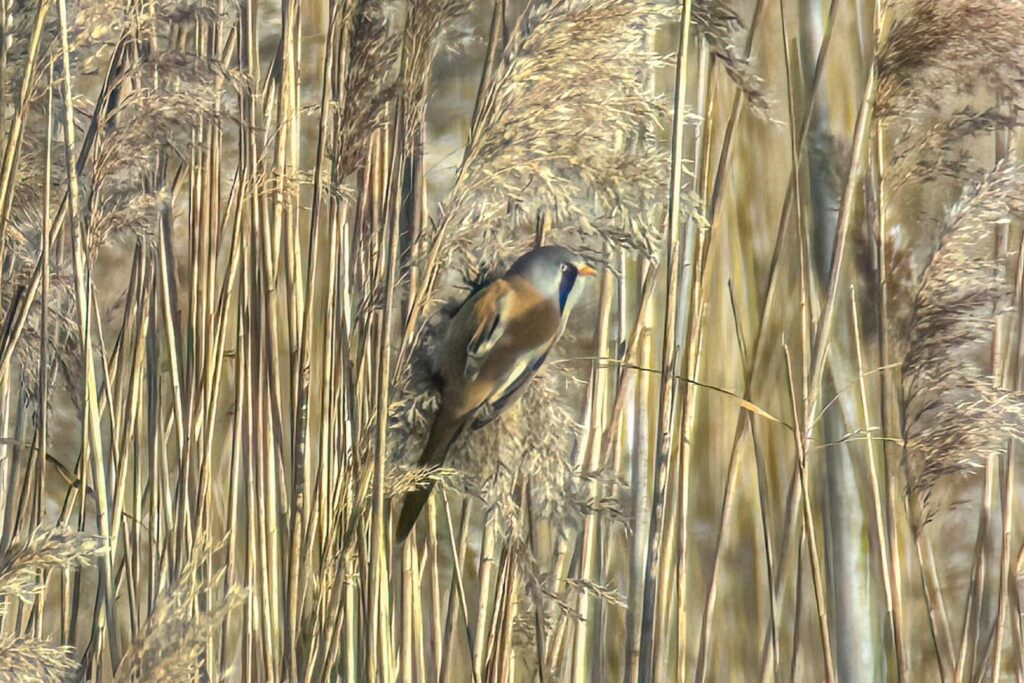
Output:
[{"xmin": 115, "ymin": 542, "xmax": 245, "ymax": 683}]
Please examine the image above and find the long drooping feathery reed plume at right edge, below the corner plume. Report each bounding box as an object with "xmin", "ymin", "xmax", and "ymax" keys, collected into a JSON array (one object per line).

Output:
[{"xmin": 902, "ymin": 165, "xmax": 1024, "ymax": 523}]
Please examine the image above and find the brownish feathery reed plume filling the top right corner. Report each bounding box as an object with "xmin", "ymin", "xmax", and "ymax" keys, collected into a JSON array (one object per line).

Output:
[{"xmin": 878, "ymin": 0, "xmax": 1024, "ymax": 117}]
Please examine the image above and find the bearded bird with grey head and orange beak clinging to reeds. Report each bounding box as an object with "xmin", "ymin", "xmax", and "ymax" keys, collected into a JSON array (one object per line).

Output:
[{"xmin": 395, "ymin": 245, "xmax": 597, "ymax": 545}]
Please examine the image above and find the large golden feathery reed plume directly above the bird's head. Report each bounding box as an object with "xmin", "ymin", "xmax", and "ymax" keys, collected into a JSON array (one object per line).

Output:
[{"xmin": 439, "ymin": 0, "xmax": 671, "ymax": 267}]
